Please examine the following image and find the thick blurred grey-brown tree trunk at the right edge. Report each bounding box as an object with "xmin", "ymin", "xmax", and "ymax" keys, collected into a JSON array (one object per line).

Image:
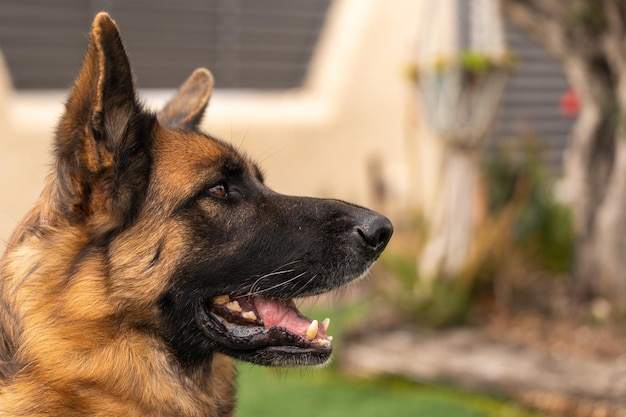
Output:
[{"xmin": 502, "ymin": 0, "xmax": 626, "ymax": 304}]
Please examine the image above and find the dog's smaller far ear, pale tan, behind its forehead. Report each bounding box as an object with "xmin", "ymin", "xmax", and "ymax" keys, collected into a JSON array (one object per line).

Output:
[{"xmin": 157, "ymin": 68, "xmax": 213, "ymax": 130}]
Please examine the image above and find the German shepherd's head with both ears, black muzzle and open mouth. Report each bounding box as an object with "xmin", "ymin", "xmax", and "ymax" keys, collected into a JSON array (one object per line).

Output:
[{"xmin": 50, "ymin": 14, "xmax": 392, "ymax": 365}]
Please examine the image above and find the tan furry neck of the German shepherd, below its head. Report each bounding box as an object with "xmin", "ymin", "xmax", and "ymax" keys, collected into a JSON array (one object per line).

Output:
[{"xmin": 0, "ymin": 226, "xmax": 236, "ymax": 417}]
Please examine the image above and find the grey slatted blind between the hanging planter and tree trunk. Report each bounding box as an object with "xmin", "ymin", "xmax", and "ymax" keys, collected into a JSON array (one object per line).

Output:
[{"xmin": 491, "ymin": 24, "xmax": 573, "ymax": 174}]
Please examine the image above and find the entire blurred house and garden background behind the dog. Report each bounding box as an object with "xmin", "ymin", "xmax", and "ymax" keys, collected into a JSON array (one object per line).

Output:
[{"xmin": 0, "ymin": 0, "xmax": 626, "ymax": 417}]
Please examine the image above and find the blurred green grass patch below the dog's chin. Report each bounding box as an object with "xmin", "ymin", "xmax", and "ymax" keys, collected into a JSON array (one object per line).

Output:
[{"xmin": 235, "ymin": 364, "xmax": 537, "ymax": 417}]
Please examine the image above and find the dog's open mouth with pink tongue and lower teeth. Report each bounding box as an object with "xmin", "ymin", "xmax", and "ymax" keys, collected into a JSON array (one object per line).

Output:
[{"xmin": 197, "ymin": 295, "xmax": 332, "ymax": 364}]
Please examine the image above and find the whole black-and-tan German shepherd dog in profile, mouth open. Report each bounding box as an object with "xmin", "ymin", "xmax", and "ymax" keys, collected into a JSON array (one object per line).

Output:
[{"xmin": 0, "ymin": 13, "xmax": 392, "ymax": 417}]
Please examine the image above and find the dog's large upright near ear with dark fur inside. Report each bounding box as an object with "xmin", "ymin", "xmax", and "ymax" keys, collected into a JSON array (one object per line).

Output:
[{"xmin": 56, "ymin": 13, "xmax": 155, "ymax": 227}]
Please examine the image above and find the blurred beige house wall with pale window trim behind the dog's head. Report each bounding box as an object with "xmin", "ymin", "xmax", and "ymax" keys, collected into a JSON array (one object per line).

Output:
[{"xmin": 0, "ymin": 0, "xmax": 446, "ymax": 245}]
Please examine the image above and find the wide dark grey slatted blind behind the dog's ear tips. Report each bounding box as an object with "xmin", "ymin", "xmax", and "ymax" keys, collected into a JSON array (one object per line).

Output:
[{"xmin": 0, "ymin": 0, "xmax": 330, "ymax": 89}]
